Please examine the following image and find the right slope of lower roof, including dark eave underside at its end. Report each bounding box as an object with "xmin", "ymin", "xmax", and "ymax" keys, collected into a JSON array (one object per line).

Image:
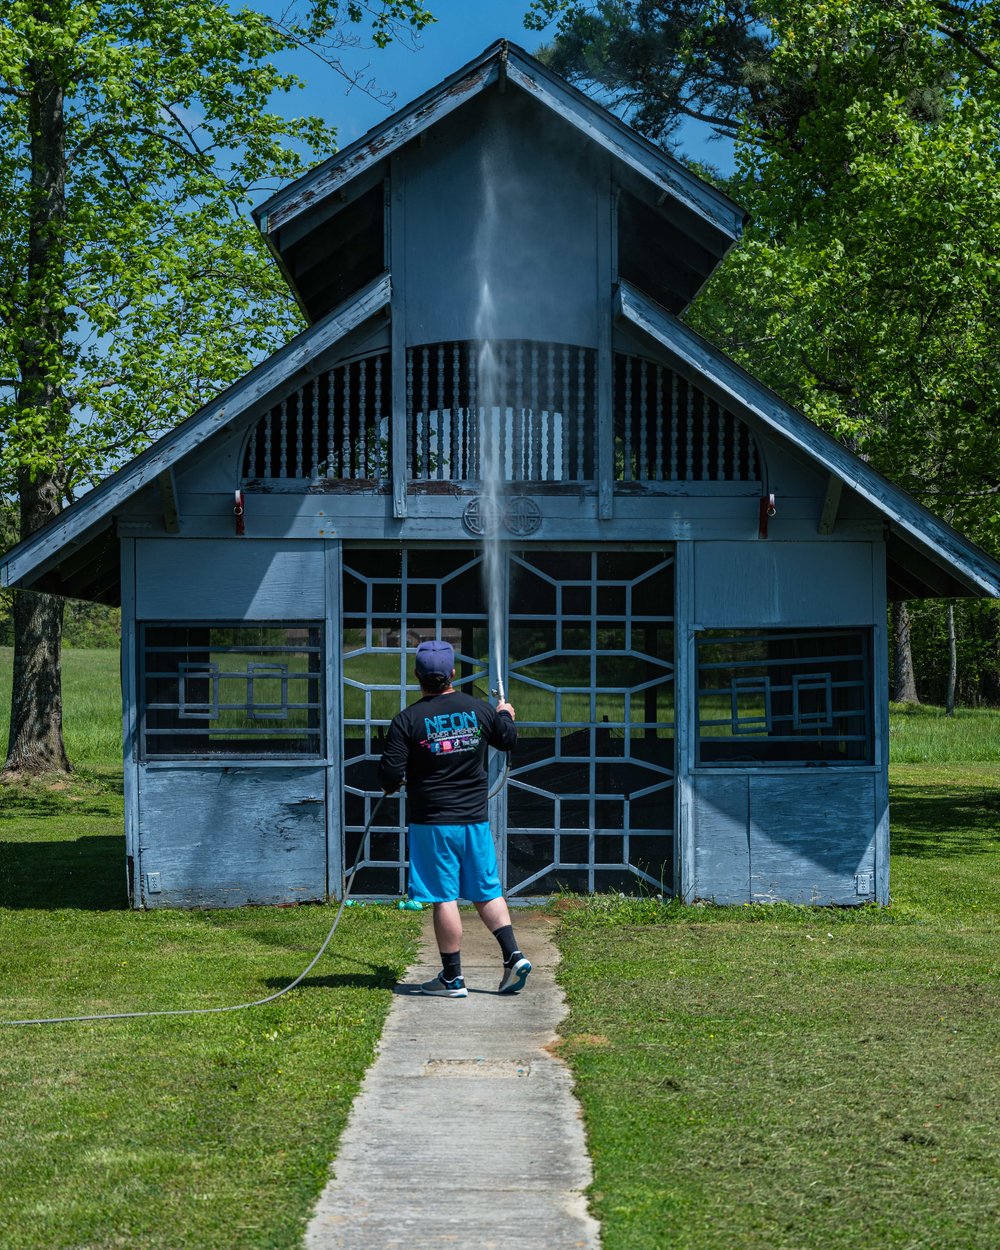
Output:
[{"xmin": 615, "ymin": 281, "xmax": 1000, "ymax": 599}]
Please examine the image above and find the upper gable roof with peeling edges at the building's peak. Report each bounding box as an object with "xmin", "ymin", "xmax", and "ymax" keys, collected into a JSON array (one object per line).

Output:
[{"xmin": 254, "ymin": 40, "xmax": 748, "ymax": 315}]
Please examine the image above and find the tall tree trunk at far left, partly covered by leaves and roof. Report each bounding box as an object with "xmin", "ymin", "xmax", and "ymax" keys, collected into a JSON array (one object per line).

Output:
[{"xmin": 4, "ymin": 46, "xmax": 70, "ymax": 773}]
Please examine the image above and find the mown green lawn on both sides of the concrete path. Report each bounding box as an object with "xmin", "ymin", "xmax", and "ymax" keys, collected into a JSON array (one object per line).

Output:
[{"xmin": 0, "ymin": 650, "xmax": 1000, "ymax": 1250}]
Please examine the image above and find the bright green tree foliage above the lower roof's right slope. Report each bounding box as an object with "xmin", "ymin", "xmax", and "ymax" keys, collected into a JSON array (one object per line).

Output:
[{"xmin": 693, "ymin": 0, "xmax": 1000, "ymax": 549}]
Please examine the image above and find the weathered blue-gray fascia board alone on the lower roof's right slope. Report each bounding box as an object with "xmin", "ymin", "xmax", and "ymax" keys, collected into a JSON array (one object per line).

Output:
[{"xmin": 616, "ymin": 281, "xmax": 1000, "ymax": 598}]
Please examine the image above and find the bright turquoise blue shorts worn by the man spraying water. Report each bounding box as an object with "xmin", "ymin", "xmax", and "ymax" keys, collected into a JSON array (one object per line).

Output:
[{"xmin": 410, "ymin": 820, "xmax": 504, "ymax": 903}]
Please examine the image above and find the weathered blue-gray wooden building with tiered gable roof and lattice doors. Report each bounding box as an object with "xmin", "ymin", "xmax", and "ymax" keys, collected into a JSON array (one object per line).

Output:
[{"xmin": 3, "ymin": 43, "xmax": 1000, "ymax": 908}]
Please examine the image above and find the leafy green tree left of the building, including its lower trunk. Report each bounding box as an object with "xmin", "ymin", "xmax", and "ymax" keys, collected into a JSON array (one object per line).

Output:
[{"xmin": 0, "ymin": 0, "xmax": 431, "ymax": 773}]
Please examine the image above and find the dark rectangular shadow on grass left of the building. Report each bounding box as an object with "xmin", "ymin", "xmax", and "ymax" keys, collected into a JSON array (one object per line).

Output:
[{"xmin": 0, "ymin": 840, "xmax": 129, "ymax": 911}]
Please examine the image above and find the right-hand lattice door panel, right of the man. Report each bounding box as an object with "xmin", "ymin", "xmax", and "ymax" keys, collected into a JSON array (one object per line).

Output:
[{"xmin": 506, "ymin": 551, "xmax": 675, "ymax": 895}]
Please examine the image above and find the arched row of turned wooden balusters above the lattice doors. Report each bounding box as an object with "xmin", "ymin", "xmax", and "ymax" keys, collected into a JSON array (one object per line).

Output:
[{"xmin": 243, "ymin": 340, "xmax": 760, "ymax": 490}]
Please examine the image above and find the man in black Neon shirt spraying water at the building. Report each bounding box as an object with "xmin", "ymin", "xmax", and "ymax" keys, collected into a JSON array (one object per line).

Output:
[{"xmin": 379, "ymin": 639, "xmax": 531, "ymax": 999}]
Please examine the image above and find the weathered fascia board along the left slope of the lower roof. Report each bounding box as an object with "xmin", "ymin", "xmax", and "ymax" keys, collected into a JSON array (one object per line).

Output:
[{"xmin": 0, "ymin": 274, "xmax": 391, "ymax": 586}]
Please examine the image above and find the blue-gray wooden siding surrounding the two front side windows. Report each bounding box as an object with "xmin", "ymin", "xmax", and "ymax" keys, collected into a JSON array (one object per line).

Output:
[{"xmin": 123, "ymin": 525, "xmax": 888, "ymax": 906}]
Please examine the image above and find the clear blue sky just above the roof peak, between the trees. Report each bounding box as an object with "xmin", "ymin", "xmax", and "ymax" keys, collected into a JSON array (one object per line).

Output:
[{"xmin": 263, "ymin": 0, "xmax": 733, "ymax": 170}]
